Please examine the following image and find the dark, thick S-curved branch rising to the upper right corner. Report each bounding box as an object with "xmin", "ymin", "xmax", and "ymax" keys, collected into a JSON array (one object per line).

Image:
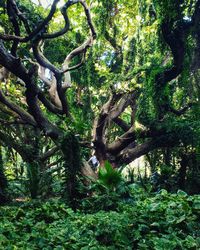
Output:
[{"xmin": 155, "ymin": 0, "xmax": 200, "ymax": 119}]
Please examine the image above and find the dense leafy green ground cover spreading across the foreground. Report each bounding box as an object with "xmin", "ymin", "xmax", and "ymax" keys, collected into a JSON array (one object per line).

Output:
[{"xmin": 0, "ymin": 190, "xmax": 200, "ymax": 250}]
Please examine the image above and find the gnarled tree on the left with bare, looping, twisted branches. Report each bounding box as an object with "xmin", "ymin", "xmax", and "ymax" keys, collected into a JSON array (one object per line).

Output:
[{"xmin": 0, "ymin": 0, "xmax": 96, "ymax": 202}]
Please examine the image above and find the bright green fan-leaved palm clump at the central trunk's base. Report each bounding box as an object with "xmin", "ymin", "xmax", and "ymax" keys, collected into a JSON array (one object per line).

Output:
[{"xmin": 79, "ymin": 161, "xmax": 129, "ymax": 213}]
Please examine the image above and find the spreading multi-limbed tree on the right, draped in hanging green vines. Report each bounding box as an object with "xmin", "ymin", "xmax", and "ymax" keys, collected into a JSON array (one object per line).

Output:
[{"xmin": 94, "ymin": 1, "xmax": 200, "ymax": 168}]
